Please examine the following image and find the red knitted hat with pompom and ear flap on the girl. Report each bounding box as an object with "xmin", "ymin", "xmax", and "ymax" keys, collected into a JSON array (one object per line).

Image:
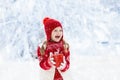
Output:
[{"xmin": 43, "ymin": 17, "xmax": 62, "ymax": 41}]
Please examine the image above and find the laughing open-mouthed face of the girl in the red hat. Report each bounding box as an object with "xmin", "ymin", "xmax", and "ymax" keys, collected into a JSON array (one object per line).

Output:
[{"xmin": 51, "ymin": 27, "xmax": 63, "ymax": 42}]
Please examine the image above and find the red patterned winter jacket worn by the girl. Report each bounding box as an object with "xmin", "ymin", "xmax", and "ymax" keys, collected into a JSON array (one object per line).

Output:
[{"xmin": 37, "ymin": 41, "xmax": 70, "ymax": 72}]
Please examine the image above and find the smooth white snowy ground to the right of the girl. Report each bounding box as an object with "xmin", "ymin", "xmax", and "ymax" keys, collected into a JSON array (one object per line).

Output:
[{"xmin": 73, "ymin": 56, "xmax": 120, "ymax": 80}]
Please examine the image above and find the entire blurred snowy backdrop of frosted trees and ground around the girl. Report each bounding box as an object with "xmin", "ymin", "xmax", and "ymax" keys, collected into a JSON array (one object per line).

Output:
[{"xmin": 0, "ymin": 0, "xmax": 120, "ymax": 80}]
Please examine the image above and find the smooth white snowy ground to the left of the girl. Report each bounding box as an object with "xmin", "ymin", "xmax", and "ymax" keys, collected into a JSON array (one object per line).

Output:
[{"xmin": 0, "ymin": 61, "xmax": 39, "ymax": 80}]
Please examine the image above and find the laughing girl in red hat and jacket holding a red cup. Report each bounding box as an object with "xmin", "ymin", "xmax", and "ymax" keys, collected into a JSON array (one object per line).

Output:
[{"xmin": 37, "ymin": 17, "xmax": 70, "ymax": 80}]
